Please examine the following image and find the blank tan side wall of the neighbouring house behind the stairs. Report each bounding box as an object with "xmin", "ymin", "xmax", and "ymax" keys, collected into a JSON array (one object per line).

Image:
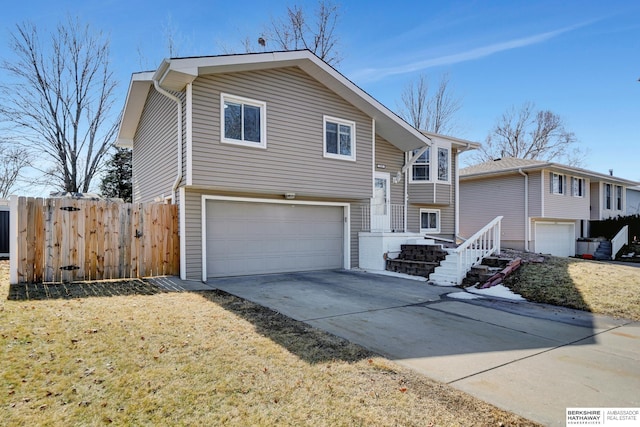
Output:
[{"xmin": 460, "ymin": 174, "xmax": 526, "ymax": 247}]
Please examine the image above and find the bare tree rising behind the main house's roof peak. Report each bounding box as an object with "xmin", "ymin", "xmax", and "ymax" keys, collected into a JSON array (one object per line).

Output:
[{"xmin": 242, "ymin": 0, "xmax": 342, "ymax": 66}]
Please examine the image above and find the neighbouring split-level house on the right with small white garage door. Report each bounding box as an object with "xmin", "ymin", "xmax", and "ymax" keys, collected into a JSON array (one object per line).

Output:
[{"xmin": 460, "ymin": 157, "xmax": 638, "ymax": 256}]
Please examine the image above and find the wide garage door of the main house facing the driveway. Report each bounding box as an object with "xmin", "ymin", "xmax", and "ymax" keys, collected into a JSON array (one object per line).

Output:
[{"xmin": 206, "ymin": 200, "xmax": 344, "ymax": 277}]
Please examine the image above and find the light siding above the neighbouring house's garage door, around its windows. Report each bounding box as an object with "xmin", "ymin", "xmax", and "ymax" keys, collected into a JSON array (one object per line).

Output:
[{"xmin": 544, "ymin": 171, "xmax": 589, "ymax": 219}]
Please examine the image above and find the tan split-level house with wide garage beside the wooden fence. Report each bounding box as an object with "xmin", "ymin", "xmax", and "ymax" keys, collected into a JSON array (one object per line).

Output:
[{"xmin": 118, "ymin": 50, "xmax": 477, "ymax": 280}]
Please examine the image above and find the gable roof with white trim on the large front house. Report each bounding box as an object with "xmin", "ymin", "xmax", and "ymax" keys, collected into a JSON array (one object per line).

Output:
[{"xmin": 117, "ymin": 50, "xmax": 477, "ymax": 152}]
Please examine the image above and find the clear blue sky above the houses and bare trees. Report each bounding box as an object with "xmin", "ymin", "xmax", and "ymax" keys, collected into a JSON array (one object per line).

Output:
[{"xmin": 0, "ymin": 0, "xmax": 640, "ymax": 186}]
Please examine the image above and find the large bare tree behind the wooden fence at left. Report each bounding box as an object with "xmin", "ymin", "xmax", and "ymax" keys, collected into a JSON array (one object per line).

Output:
[{"xmin": 0, "ymin": 18, "xmax": 118, "ymax": 192}]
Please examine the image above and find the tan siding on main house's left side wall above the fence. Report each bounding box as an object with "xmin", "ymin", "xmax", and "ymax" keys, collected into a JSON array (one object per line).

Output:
[{"xmin": 133, "ymin": 88, "xmax": 178, "ymax": 202}]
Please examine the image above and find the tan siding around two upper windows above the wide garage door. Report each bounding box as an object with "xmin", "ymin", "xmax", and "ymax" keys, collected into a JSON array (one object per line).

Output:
[{"xmin": 188, "ymin": 68, "xmax": 373, "ymax": 199}]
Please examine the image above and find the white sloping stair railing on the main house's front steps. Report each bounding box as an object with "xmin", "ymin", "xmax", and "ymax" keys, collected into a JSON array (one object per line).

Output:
[{"xmin": 455, "ymin": 216, "xmax": 503, "ymax": 283}]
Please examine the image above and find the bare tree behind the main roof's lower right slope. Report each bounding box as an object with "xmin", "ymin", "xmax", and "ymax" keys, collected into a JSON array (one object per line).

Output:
[{"xmin": 399, "ymin": 74, "xmax": 462, "ymax": 134}]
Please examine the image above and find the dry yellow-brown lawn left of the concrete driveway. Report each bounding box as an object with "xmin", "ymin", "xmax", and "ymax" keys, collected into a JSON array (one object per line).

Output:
[{"xmin": 0, "ymin": 262, "xmax": 534, "ymax": 426}]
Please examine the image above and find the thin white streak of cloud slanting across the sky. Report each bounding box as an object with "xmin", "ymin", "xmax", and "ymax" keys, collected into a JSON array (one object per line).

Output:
[{"xmin": 351, "ymin": 23, "xmax": 587, "ymax": 82}]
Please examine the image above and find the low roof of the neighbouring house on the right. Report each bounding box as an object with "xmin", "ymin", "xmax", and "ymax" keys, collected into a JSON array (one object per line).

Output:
[{"xmin": 460, "ymin": 157, "xmax": 639, "ymax": 186}]
